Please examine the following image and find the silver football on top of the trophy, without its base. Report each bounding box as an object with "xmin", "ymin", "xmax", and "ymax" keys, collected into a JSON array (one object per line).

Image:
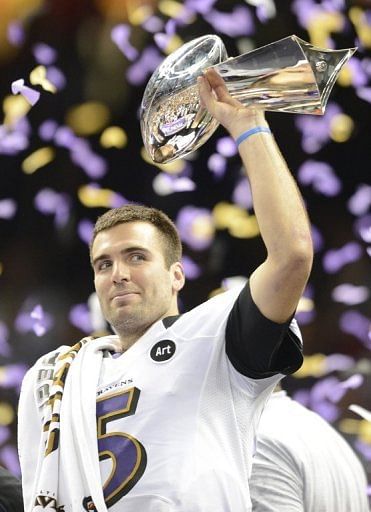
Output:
[{"xmin": 140, "ymin": 35, "xmax": 228, "ymax": 162}]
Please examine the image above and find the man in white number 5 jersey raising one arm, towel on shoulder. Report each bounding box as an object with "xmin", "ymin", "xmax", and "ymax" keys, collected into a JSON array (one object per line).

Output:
[{"xmin": 19, "ymin": 70, "xmax": 313, "ymax": 512}]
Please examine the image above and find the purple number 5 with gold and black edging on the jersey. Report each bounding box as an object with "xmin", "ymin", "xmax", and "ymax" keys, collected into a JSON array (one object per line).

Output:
[{"xmin": 97, "ymin": 388, "xmax": 147, "ymax": 507}]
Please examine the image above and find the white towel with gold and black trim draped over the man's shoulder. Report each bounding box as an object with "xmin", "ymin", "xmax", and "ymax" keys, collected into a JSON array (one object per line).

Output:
[{"xmin": 18, "ymin": 336, "xmax": 120, "ymax": 512}]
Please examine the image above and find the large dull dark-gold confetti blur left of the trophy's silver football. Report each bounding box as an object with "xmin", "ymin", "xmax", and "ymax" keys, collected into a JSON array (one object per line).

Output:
[{"xmin": 66, "ymin": 101, "xmax": 111, "ymax": 136}]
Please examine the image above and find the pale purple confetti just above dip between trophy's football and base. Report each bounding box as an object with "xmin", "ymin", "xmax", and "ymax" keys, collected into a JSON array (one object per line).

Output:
[{"xmin": 204, "ymin": 6, "xmax": 255, "ymax": 37}]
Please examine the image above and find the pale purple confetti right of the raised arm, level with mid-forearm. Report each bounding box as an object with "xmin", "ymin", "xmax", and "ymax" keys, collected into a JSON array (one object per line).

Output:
[{"xmin": 298, "ymin": 160, "xmax": 341, "ymax": 197}]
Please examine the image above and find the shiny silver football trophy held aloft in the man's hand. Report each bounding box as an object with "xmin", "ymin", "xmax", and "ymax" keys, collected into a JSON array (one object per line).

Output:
[{"xmin": 140, "ymin": 35, "xmax": 356, "ymax": 163}]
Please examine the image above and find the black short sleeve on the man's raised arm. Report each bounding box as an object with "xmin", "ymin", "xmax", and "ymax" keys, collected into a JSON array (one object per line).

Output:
[{"xmin": 226, "ymin": 282, "xmax": 303, "ymax": 379}]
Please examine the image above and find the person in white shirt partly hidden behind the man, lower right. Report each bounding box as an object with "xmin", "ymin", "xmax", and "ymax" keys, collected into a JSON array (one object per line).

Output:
[{"xmin": 249, "ymin": 391, "xmax": 369, "ymax": 512}]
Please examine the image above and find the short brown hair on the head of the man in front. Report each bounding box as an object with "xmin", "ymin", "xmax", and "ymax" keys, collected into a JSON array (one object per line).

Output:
[{"xmin": 89, "ymin": 204, "xmax": 182, "ymax": 268}]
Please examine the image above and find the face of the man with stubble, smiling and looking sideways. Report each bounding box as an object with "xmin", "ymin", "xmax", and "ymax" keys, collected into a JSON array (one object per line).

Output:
[{"xmin": 92, "ymin": 222, "xmax": 184, "ymax": 338}]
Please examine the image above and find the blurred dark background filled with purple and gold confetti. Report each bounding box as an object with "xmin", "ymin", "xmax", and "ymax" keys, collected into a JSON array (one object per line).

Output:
[{"xmin": 0, "ymin": 0, "xmax": 371, "ymax": 496}]
